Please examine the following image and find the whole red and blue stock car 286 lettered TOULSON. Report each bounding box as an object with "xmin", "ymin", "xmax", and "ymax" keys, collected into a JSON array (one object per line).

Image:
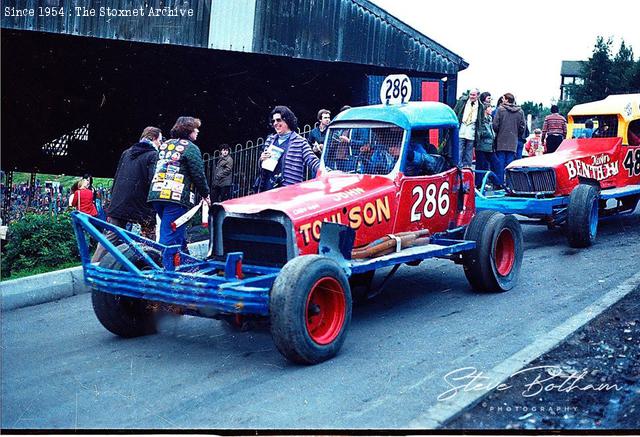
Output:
[{"xmin": 74, "ymin": 102, "xmax": 523, "ymax": 364}]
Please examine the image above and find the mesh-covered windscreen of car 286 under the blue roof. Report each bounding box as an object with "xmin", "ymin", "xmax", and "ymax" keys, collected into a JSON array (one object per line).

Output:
[{"xmin": 323, "ymin": 125, "xmax": 404, "ymax": 175}]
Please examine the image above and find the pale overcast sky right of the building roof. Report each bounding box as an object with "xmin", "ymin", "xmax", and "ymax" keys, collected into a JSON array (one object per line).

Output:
[{"xmin": 371, "ymin": 0, "xmax": 640, "ymax": 105}]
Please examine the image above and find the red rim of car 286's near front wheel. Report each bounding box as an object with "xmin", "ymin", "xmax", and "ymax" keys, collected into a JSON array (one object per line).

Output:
[{"xmin": 304, "ymin": 277, "xmax": 347, "ymax": 345}]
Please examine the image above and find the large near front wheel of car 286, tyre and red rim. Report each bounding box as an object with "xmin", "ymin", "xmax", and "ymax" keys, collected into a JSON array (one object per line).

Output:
[{"xmin": 269, "ymin": 255, "xmax": 351, "ymax": 364}]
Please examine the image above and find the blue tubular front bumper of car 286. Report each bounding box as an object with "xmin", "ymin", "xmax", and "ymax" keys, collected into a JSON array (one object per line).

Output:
[{"xmin": 72, "ymin": 212, "xmax": 280, "ymax": 316}]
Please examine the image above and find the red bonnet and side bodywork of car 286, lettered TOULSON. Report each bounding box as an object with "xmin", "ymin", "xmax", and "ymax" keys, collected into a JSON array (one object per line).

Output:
[{"xmin": 222, "ymin": 169, "xmax": 475, "ymax": 255}]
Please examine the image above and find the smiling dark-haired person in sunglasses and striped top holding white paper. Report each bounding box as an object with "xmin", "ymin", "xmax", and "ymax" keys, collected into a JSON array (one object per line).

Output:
[{"xmin": 259, "ymin": 106, "xmax": 320, "ymax": 191}]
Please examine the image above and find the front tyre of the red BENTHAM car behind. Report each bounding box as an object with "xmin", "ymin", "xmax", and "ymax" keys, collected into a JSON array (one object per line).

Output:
[{"xmin": 567, "ymin": 184, "xmax": 600, "ymax": 248}]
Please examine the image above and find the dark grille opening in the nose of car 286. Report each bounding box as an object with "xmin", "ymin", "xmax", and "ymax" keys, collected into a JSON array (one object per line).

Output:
[{"xmin": 222, "ymin": 217, "xmax": 287, "ymax": 266}]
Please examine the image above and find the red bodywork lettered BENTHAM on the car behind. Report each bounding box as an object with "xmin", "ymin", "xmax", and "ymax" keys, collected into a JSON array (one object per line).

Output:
[{"xmin": 508, "ymin": 137, "xmax": 640, "ymax": 196}]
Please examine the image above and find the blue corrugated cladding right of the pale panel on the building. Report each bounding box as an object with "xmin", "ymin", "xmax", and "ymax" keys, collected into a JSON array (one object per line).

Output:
[{"xmin": 253, "ymin": 0, "xmax": 469, "ymax": 74}]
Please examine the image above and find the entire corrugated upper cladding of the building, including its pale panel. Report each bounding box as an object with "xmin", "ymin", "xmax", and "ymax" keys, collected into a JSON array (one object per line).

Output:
[{"xmin": 1, "ymin": 0, "xmax": 469, "ymax": 75}]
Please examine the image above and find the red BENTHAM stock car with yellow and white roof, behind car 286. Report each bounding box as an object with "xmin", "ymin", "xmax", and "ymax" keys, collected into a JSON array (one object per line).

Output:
[{"xmin": 476, "ymin": 94, "xmax": 640, "ymax": 247}]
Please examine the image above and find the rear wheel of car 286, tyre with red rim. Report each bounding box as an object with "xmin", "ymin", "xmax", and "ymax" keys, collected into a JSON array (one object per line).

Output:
[{"xmin": 462, "ymin": 211, "xmax": 524, "ymax": 292}]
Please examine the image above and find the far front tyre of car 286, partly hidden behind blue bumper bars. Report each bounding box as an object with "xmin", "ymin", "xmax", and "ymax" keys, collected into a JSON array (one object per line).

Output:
[{"xmin": 91, "ymin": 244, "xmax": 161, "ymax": 338}]
